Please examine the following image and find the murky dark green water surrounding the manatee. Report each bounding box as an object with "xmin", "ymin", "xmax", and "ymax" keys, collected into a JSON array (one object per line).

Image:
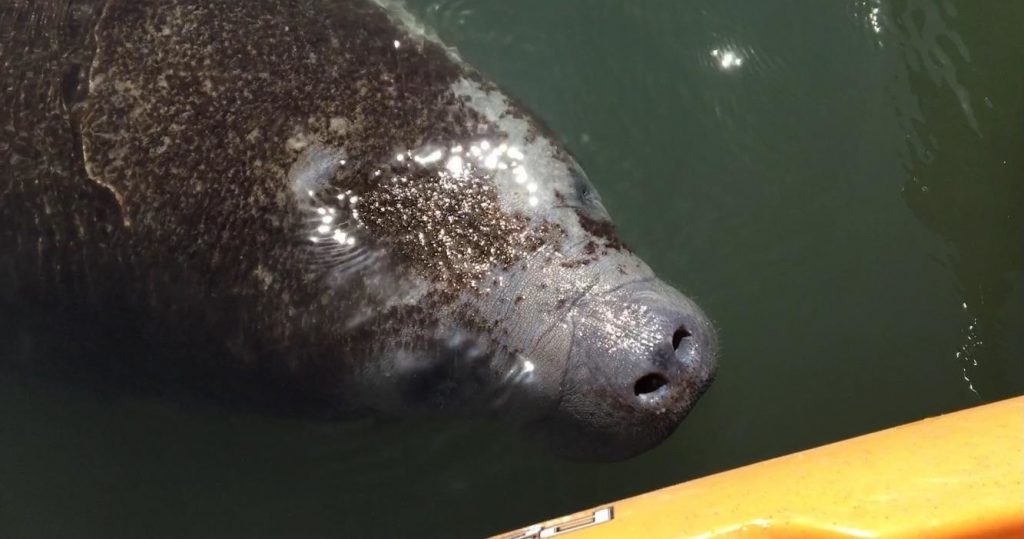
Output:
[{"xmin": 0, "ymin": 0, "xmax": 1024, "ymax": 538}]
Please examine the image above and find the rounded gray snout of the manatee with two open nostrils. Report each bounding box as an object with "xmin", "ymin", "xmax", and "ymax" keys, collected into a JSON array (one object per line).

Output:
[{"xmin": 535, "ymin": 279, "xmax": 718, "ymax": 460}]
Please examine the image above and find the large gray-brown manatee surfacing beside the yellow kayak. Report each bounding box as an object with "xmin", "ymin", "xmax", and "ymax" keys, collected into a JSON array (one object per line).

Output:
[{"xmin": 0, "ymin": 0, "xmax": 717, "ymax": 458}]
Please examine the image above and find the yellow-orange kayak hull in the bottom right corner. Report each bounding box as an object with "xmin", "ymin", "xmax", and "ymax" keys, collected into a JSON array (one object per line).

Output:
[{"xmin": 497, "ymin": 397, "xmax": 1024, "ymax": 539}]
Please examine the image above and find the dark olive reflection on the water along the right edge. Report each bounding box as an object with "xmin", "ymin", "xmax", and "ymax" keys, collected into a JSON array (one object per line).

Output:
[{"xmin": 891, "ymin": 0, "xmax": 1024, "ymax": 396}]
